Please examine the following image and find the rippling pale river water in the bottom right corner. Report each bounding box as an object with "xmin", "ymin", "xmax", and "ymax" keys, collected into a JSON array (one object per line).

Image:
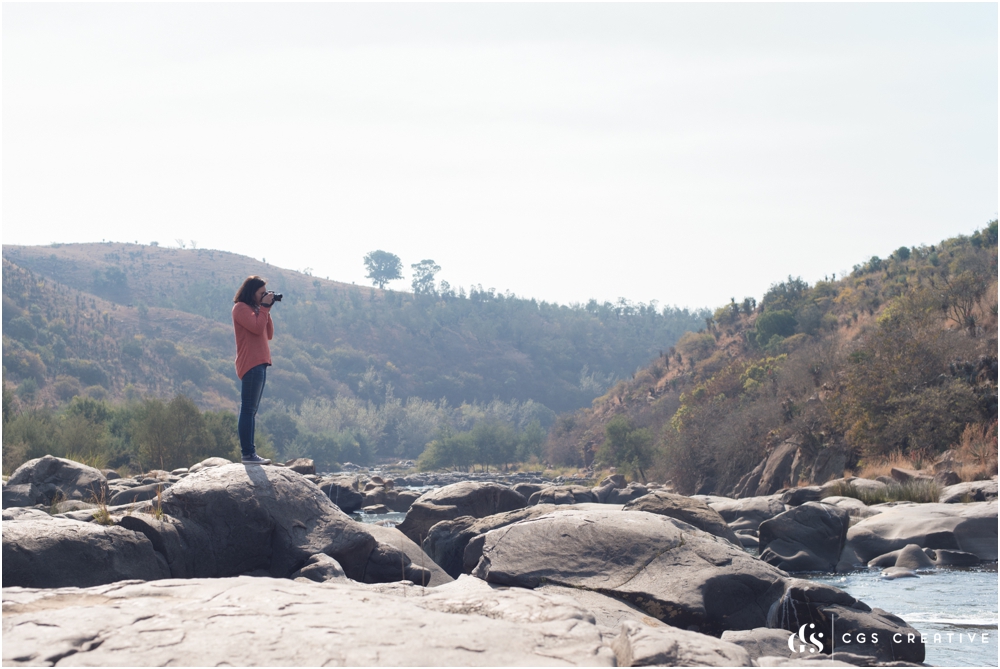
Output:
[{"xmin": 802, "ymin": 562, "xmax": 998, "ymax": 667}]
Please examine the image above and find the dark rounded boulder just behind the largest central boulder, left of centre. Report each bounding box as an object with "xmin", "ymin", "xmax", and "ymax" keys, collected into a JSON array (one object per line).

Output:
[{"xmin": 396, "ymin": 481, "xmax": 528, "ymax": 545}]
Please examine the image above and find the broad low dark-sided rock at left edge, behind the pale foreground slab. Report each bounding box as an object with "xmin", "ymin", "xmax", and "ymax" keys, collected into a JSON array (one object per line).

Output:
[{"xmin": 3, "ymin": 515, "xmax": 170, "ymax": 588}]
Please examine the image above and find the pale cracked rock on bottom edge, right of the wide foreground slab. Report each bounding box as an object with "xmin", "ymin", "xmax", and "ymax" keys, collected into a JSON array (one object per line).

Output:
[{"xmin": 611, "ymin": 620, "xmax": 752, "ymax": 667}]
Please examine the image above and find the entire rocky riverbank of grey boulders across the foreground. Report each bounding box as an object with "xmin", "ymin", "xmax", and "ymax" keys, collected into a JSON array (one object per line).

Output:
[{"xmin": 3, "ymin": 457, "xmax": 997, "ymax": 666}]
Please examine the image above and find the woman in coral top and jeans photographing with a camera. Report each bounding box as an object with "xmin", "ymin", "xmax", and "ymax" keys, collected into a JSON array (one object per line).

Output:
[{"xmin": 233, "ymin": 275, "xmax": 274, "ymax": 465}]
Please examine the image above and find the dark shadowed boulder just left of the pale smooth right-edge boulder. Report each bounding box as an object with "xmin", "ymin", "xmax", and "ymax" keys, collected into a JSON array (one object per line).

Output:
[{"xmin": 758, "ymin": 502, "xmax": 850, "ymax": 572}]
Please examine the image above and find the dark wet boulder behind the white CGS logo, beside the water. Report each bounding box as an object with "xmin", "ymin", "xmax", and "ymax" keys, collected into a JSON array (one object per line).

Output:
[{"xmin": 767, "ymin": 579, "xmax": 924, "ymax": 662}]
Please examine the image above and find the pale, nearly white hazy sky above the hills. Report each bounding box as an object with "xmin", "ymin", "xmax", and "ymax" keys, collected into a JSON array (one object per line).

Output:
[{"xmin": 2, "ymin": 3, "xmax": 998, "ymax": 308}]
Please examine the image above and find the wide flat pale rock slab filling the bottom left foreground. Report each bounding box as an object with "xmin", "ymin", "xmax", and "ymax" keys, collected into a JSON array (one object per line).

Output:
[{"xmin": 3, "ymin": 576, "xmax": 615, "ymax": 666}]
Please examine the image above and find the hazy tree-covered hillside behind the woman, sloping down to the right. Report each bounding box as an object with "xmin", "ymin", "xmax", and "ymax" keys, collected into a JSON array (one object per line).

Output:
[{"xmin": 3, "ymin": 243, "xmax": 707, "ymax": 411}]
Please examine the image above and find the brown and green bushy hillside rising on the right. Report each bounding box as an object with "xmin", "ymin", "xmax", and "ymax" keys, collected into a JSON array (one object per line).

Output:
[{"xmin": 546, "ymin": 221, "xmax": 997, "ymax": 494}]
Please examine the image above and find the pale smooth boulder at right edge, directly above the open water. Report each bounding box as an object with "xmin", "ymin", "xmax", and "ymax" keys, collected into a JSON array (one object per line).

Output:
[{"xmin": 845, "ymin": 501, "xmax": 997, "ymax": 563}]
